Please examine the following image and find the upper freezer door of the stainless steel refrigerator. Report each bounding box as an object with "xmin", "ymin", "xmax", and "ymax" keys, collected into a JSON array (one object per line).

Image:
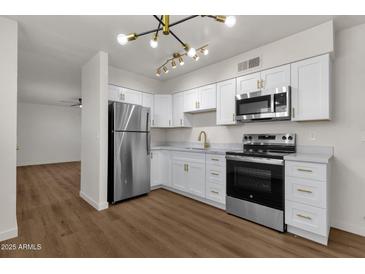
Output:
[{"xmin": 113, "ymin": 102, "xmax": 150, "ymax": 132}]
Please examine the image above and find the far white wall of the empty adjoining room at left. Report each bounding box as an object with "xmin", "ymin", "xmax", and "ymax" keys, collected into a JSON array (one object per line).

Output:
[{"xmin": 17, "ymin": 103, "xmax": 81, "ymax": 166}]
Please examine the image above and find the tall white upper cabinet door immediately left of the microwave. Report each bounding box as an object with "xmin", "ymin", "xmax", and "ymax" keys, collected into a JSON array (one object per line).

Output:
[{"xmin": 217, "ymin": 79, "xmax": 236, "ymax": 125}]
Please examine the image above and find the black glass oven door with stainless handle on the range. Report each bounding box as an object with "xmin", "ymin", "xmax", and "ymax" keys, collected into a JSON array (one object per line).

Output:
[{"xmin": 226, "ymin": 155, "xmax": 284, "ymax": 210}]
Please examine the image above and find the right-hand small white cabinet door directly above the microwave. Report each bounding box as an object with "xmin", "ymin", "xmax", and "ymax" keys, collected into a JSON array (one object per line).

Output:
[{"xmin": 260, "ymin": 65, "xmax": 290, "ymax": 89}]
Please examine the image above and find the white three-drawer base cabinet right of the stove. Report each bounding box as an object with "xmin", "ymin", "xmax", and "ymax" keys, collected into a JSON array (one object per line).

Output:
[{"xmin": 285, "ymin": 160, "xmax": 330, "ymax": 245}]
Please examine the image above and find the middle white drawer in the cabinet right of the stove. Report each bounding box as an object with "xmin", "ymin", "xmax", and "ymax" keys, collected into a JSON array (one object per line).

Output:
[{"xmin": 285, "ymin": 176, "xmax": 327, "ymax": 208}]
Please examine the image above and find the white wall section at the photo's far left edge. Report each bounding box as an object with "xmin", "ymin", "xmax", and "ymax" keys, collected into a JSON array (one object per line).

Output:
[{"xmin": 0, "ymin": 17, "xmax": 18, "ymax": 241}]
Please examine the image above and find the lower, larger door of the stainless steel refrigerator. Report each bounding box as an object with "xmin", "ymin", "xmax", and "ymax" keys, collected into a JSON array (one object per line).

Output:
[{"xmin": 113, "ymin": 132, "xmax": 151, "ymax": 202}]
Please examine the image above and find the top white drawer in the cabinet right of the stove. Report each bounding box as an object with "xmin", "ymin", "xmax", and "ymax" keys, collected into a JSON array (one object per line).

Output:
[{"xmin": 285, "ymin": 161, "xmax": 327, "ymax": 181}]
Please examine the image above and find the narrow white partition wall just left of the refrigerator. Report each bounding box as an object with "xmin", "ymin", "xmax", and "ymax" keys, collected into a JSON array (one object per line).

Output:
[{"xmin": 80, "ymin": 52, "xmax": 108, "ymax": 210}]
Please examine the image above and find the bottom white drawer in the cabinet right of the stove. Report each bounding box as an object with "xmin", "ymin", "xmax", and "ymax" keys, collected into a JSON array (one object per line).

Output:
[{"xmin": 285, "ymin": 201, "xmax": 327, "ymax": 236}]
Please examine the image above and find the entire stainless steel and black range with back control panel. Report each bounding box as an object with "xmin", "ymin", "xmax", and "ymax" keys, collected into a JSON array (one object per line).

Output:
[{"xmin": 226, "ymin": 134, "xmax": 296, "ymax": 232}]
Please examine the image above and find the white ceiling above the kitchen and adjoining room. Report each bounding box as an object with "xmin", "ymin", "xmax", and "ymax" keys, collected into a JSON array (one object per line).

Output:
[{"xmin": 6, "ymin": 15, "xmax": 365, "ymax": 103}]
